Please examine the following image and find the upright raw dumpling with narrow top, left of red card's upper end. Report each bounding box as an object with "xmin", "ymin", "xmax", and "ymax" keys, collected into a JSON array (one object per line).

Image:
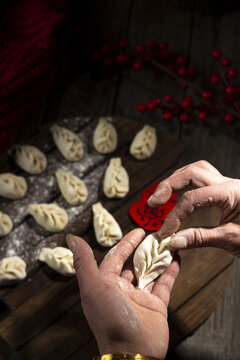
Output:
[{"xmin": 103, "ymin": 158, "xmax": 129, "ymax": 198}]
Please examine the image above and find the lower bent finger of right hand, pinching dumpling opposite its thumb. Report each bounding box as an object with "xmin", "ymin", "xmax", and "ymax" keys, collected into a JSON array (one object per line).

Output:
[{"xmin": 158, "ymin": 180, "xmax": 240, "ymax": 238}]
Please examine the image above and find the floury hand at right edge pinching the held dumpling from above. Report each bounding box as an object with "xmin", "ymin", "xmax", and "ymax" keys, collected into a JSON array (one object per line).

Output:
[{"xmin": 148, "ymin": 160, "xmax": 240, "ymax": 257}]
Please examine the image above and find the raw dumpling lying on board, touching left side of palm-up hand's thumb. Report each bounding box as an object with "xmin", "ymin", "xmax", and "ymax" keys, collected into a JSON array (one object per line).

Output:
[{"xmin": 38, "ymin": 246, "xmax": 75, "ymax": 275}]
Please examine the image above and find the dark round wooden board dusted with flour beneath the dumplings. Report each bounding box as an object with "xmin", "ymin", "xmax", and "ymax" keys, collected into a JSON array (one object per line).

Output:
[{"xmin": 0, "ymin": 118, "xmax": 233, "ymax": 360}]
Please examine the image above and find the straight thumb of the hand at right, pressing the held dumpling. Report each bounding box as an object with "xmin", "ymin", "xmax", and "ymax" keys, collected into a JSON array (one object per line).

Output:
[{"xmin": 168, "ymin": 225, "xmax": 235, "ymax": 251}]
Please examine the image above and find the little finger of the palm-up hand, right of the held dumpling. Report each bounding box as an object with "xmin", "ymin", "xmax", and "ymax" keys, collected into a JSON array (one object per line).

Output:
[{"xmin": 152, "ymin": 254, "xmax": 180, "ymax": 307}]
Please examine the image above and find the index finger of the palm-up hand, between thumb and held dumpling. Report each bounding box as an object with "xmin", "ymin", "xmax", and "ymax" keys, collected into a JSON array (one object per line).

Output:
[{"xmin": 99, "ymin": 228, "xmax": 145, "ymax": 275}]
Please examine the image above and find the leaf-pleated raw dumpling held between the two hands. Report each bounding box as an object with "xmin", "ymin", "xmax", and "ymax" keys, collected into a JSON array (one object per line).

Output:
[{"xmin": 133, "ymin": 232, "xmax": 172, "ymax": 289}]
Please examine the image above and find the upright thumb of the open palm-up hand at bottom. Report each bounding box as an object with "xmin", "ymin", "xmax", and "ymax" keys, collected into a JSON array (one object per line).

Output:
[{"xmin": 66, "ymin": 234, "xmax": 99, "ymax": 297}]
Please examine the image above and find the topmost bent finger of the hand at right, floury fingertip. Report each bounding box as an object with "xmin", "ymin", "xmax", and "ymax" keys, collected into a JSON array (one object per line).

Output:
[{"xmin": 148, "ymin": 164, "xmax": 224, "ymax": 207}]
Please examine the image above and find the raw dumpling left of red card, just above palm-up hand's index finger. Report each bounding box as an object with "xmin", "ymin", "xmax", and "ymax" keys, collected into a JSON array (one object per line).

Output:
[{"xmin": 92, "ymin": 202, "xmax": 122, "ymax": 247}]
